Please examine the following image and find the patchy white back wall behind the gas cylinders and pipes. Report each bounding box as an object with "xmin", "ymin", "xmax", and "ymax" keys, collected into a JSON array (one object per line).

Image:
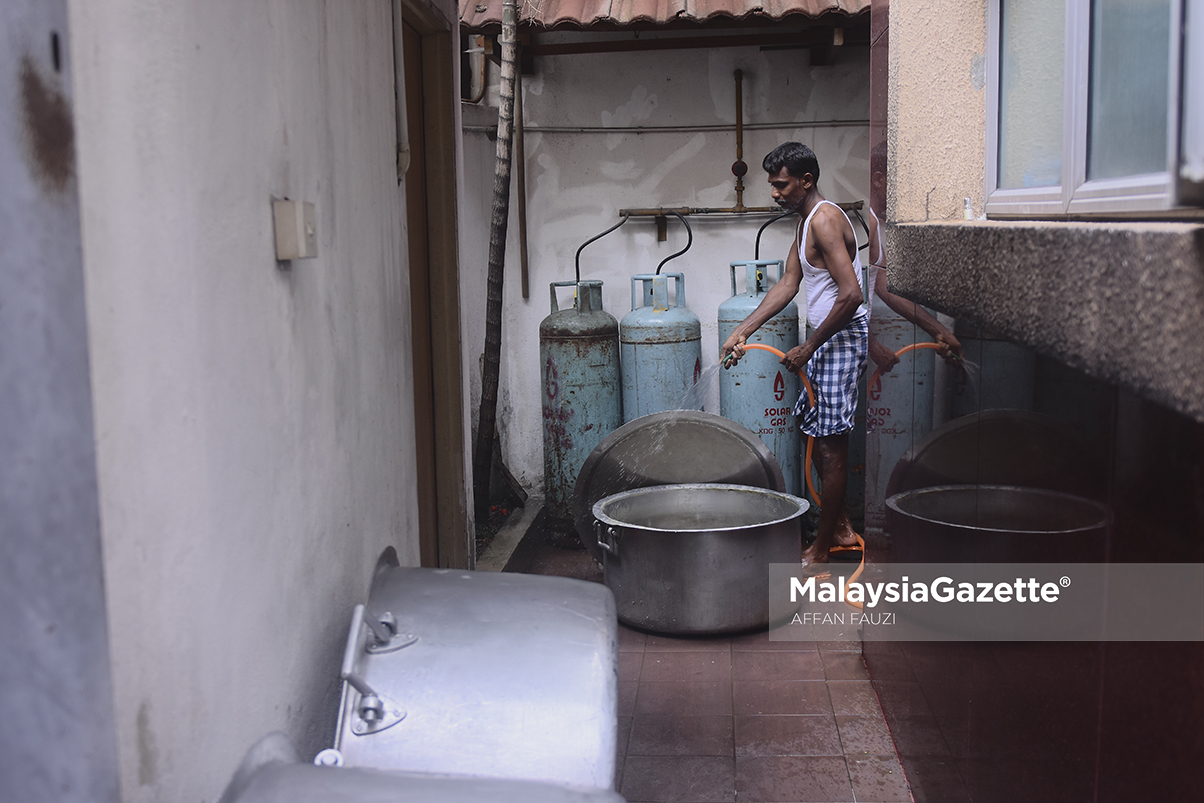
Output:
[{"xmin": 460, "ymin": 47, "xmax": 869, "ymax": 492}]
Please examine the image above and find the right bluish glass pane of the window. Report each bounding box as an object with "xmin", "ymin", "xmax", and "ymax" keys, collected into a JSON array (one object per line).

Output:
[{"xmin": 1087, "ymin": 0, "xmax": 1171, "ymax": 179}]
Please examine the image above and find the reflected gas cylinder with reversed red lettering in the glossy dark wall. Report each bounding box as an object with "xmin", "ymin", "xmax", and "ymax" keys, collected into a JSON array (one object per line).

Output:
[{"xmin": 866, "ymin": 293, "xmax": 936, "ymax": 535}]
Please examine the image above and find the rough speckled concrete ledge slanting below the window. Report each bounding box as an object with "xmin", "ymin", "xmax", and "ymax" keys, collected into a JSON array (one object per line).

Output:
[{"xmin": 887, "ymin": 222, "xmax": 1204, "ymax": 420}]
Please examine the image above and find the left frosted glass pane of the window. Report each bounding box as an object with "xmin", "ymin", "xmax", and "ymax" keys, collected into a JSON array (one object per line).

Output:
[{"xmin": 999, "ymin": 0, "xmax": 1066, "ymax": 189}]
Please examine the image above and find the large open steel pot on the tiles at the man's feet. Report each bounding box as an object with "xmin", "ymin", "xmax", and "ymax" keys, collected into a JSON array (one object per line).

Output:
[{"xmin": 594, "ymin": 483, "xmax": 808, "ymax": 634}]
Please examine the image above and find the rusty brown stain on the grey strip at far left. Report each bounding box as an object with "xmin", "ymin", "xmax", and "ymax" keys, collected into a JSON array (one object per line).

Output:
[{"xmin": 20, "ymin": 55, "xmax": 75, "ymax": 193}]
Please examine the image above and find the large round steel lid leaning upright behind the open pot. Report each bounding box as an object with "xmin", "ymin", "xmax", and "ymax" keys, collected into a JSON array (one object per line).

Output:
[{"xmin": 573, "ymin": 409, "xmax": 786, "ymax": 563}]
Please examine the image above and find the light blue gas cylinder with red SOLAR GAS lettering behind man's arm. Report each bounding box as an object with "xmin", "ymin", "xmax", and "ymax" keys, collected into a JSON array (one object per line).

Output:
[{"xmin": 719, "ymin": 259, "xmax": 802, "ymax": 495}]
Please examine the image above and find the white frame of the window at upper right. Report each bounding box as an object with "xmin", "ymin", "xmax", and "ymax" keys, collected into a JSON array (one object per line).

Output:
[{"xmin": 985, "ymin": 0, "xmax": 1204, "ymax": 218}]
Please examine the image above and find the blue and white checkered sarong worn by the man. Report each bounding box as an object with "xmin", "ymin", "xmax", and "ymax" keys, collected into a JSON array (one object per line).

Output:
[{"xmin": 793, "ymin": 315, "xmax": 869, "ymax": 438}]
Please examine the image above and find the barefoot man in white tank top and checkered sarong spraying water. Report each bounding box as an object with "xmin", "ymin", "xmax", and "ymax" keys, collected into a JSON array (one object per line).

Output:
[{"xmin": 720, "ymin": 142, "xmax": 869, "ymax": 566}]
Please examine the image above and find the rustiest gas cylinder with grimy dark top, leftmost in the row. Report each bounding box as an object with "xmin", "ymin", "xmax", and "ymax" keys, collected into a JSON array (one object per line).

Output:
[{"xmin": 539, "ymin": 279, "xmax": 622, "ymax": 532}]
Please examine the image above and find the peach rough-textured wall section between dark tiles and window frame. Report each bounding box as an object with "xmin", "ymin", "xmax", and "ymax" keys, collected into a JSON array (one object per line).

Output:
[{"xmin": 886, "ymin": 0, "xmax": 986, "ymax": 223}]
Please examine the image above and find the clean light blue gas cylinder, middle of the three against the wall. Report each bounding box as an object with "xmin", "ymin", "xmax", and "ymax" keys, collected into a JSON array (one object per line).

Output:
[{"xmin": 619, "ymin": 273, "xmax": 702, "ymax": 424}]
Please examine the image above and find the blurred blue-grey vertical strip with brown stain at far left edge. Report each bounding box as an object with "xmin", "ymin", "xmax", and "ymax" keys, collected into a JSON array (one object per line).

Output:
[{"xmin": 0, "ymin": 0, "xmax": 118, "ymax": 803}]
